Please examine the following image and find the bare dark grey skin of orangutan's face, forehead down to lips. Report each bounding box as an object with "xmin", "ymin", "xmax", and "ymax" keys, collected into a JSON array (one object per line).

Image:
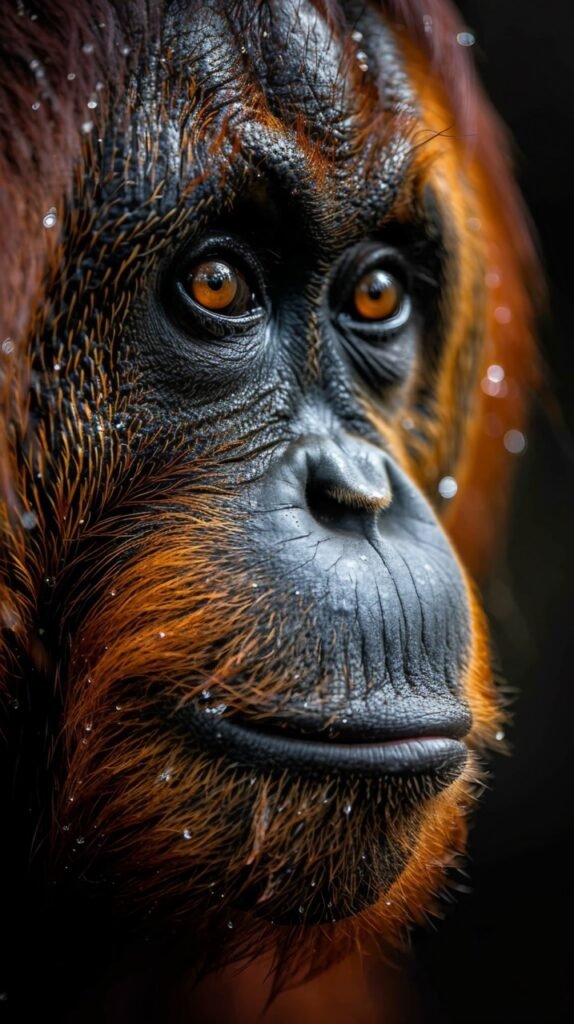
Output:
[{"xmin": 139, "ymin": 4, "xmax": 470, "ymax": 745}]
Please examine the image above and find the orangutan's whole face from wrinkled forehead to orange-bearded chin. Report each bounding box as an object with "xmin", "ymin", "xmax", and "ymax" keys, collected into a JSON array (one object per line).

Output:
[{"xmin": 16, "ymin": 3, "xmax": 478, "ymax": 937}]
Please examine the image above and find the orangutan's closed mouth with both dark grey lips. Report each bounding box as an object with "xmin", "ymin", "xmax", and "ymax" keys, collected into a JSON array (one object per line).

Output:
[{"xmin": 180, "ymin": 700, "xmax": 471, "ymax": 784}]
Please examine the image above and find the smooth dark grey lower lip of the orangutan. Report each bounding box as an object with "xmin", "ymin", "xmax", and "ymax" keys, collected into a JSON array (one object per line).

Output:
[{"xmin": 181, "ymin": 712, "xmax": 468, "ymax": 781}]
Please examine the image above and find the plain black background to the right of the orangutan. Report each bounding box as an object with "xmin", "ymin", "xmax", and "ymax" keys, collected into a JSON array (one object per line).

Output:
[{"xmin": 413, "ymin": 0, "xmax": 574, "ymax": 1024}]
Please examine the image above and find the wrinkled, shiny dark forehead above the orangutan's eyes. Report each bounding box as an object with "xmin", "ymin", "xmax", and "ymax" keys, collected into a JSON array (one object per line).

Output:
[{"xmin": 126, "ymin": 0, "xmax": 413, "ymax": 222}]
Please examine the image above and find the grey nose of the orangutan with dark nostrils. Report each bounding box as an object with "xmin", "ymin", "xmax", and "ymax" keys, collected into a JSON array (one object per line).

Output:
[{"xmin": 273, "ymin": 434, "xmax": 392, "ymax": 536}]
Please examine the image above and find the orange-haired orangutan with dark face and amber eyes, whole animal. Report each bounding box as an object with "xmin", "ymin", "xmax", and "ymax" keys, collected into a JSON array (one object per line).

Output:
[{"xmin": 0, "ymin": 0, "xmax": 536, "ymax": 1022}]
